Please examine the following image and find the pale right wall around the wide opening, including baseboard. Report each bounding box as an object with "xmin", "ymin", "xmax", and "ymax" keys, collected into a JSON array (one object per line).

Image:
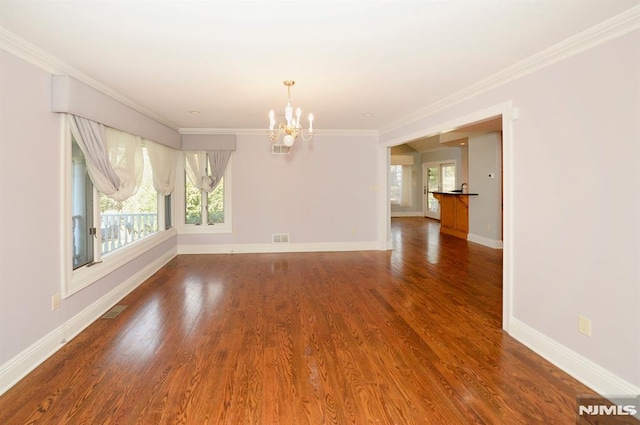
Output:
[{"xmin": 381, "ymin": 30, "xmax": 640, "ymax": 394}]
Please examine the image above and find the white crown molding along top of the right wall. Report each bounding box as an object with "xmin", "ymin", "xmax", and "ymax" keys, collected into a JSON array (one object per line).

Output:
[{"xmin": 379, "ymin": 6, "xmax": 640, "ymax": 134}]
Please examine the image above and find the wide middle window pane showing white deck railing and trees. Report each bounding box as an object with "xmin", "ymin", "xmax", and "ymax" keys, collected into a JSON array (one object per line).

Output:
[{"xmin": 100, "ymin": 148, "xmax": 158, "ymax": 254}]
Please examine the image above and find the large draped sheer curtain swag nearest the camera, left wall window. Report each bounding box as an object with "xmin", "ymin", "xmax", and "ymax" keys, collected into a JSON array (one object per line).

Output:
[{"xmin": 67, "ymin": 115, "xmax": 144, "ymax": 201}]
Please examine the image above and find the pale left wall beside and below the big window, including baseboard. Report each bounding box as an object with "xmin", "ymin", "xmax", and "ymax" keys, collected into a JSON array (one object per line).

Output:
[{"xmin": 0, "ymin": 51, "xmax": 177, "ymax": 393}]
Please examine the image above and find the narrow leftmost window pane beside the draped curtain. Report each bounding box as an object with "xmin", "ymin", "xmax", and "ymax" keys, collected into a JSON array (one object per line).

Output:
[{"xmin": 71, "ymin": 140, "xmax": 93, "ymax": 269}]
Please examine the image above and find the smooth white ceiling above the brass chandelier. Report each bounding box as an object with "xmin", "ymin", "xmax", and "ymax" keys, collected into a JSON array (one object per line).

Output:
[{"xmin": 0, "ymin": 0, "xmax": 640, "ymax": 130}]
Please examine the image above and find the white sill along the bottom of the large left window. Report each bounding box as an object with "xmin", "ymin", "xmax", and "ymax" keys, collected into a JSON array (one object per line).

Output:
[{"xmin": 63, "ymin": 228, "xmax": 178, "ymax": 298}]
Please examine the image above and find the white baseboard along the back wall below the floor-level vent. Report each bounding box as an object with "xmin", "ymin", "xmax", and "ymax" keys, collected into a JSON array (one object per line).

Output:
[{"xmin": 178, "ymin": 241, "xmax": 380, "ymax": 254}]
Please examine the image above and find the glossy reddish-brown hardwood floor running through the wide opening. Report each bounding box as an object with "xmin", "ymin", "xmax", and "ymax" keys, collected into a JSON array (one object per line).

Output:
[{"xmin": 0, "ymin": 218, "xmax": 604, "ymax": 425}]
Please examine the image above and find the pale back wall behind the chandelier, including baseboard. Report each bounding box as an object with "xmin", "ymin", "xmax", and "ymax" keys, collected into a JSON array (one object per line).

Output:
[{"xmin": 178, "ymin": 134, "xmax": 380, "ymax": 252}]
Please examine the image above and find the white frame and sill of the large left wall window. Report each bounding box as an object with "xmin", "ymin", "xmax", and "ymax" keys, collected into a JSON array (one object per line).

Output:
[{"xmin": 60, "ymin": 115, "xmax": 178, "ymax": 299}]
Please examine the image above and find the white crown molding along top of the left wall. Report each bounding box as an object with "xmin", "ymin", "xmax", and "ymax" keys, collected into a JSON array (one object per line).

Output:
[{"xmin": 0, "ymin": 27, "xmax": 178, "ymax": 131}]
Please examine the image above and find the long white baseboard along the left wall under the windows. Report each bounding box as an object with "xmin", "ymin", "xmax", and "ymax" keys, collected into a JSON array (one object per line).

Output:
[{"xmin": 0, "ymin": 249, "xmax": 177, "ymax": 395}]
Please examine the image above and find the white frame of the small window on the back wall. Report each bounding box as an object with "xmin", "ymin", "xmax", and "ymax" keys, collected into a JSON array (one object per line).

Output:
[{"xmin": 173, "ymin": 155, "xmax": 233, "ymax": 234}]
